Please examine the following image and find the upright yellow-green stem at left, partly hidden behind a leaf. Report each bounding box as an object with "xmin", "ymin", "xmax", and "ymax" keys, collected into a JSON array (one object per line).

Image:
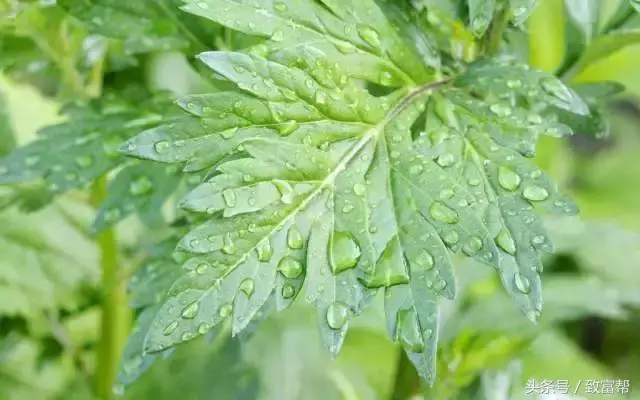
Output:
[{"xmin": 91, "ymin": 177, "xmax": 131, "ymax": 400}]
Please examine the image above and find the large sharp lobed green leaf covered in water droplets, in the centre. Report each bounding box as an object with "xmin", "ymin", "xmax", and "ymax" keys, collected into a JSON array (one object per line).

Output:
[{"xmin": 122, "ymin": 0, "xmax": 588, "ymax": 381}]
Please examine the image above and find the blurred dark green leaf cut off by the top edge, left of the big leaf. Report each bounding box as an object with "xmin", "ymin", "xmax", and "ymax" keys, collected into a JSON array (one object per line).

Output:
[{"xmin": 57, "ymin": 0, "xmax": 218, "ymax": 54}]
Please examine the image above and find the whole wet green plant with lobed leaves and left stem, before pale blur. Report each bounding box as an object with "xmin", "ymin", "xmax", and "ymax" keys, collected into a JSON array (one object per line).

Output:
[{"xmin": 0, "ymin": 0, "xmax": 639, "ymax": 398}]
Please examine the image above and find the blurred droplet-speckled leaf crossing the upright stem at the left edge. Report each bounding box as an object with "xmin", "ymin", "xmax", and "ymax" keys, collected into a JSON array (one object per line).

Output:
[{"xmin": 0, "ymin": 90, "xmax": 170, "ymax": 198}]
